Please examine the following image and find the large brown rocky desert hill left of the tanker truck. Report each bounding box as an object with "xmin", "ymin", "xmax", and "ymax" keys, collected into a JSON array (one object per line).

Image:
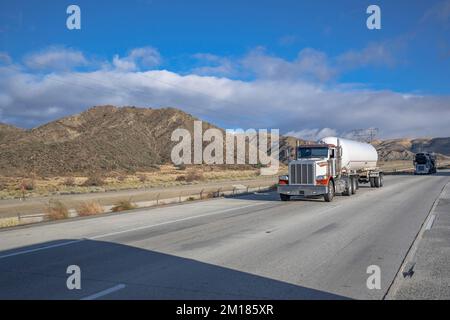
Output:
[{"xmin": 0, "ymin": 106, "xmax": 219, "ymax": 175}]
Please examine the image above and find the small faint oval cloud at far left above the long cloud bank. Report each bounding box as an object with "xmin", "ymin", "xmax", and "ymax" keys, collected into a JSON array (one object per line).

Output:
[{"xmin": 24, "ymin": 47, "xmax": 88, "ymax": 71}]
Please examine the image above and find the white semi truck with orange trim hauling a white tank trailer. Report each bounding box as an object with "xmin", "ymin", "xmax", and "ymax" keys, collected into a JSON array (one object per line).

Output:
[{"xmin": 277, "ymin": 137, "xmax": 383, "ymax": 202}]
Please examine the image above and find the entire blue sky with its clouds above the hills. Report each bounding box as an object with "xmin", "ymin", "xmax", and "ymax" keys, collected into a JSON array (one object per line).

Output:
[{"xmin": 0, "ymin": 0, "xmax": 450, "ymax": 137}]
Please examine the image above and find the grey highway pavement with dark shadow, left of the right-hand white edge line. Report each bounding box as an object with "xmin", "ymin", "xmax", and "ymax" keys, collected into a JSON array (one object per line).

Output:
[{"xmin": 0, "ymin": 171, "xmax": 450, "ymax": 299}]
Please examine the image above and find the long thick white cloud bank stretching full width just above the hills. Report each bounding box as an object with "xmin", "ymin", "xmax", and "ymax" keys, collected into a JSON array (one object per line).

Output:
[{"xmin": 0, "ymin": 46, "xmax": 450, "ymax": 140}]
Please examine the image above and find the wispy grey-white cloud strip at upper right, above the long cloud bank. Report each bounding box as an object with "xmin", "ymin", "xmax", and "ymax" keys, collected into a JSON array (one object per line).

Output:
[{"xmin": 191, "ymin": 40, "xmax": 403, "ymax": 83}]
